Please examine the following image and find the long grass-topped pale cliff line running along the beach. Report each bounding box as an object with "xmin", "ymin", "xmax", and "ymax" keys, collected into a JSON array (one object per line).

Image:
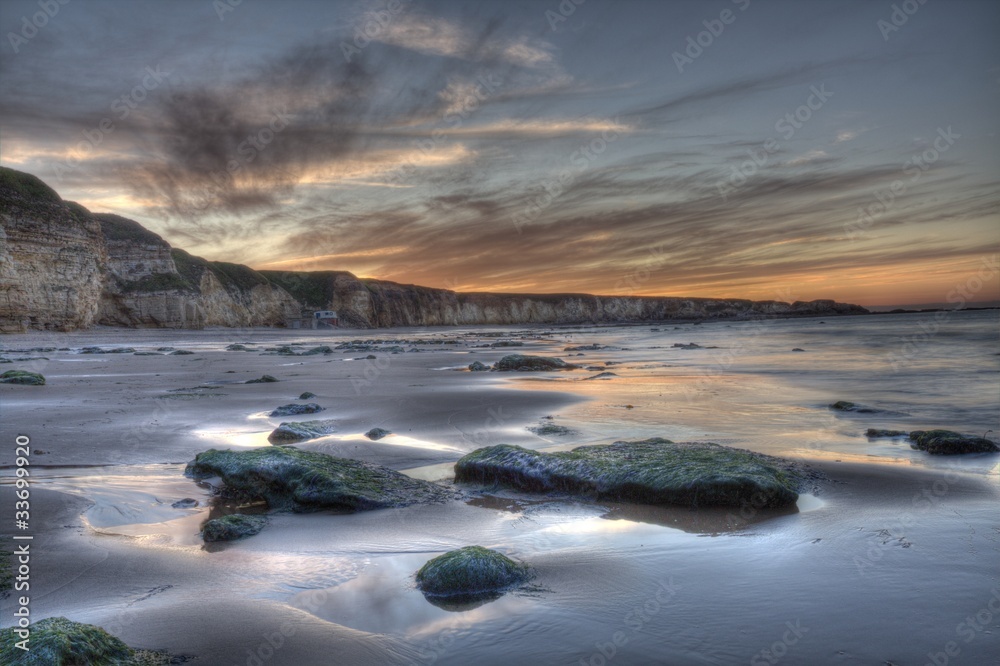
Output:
[{"xmin": 0, "ymin": 167, "xmax": 867, "ymax": 332}]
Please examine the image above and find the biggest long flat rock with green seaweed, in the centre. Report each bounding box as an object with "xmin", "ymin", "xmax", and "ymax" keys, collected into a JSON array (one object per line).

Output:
[{"xmin": 455, "ymin": 438, "xmax": 799, "ymax": 507}]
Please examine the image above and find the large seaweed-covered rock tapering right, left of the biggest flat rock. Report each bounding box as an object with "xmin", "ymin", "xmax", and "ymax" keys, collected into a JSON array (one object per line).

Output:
[{"xmin": 185, "ymin": 447, "xmax": 452, "ymax": 511}]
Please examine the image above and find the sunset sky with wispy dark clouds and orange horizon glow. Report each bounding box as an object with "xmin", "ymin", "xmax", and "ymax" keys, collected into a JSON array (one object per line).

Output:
[{"xmin": 0, "ymin": 0, "xmax": 1000, "ymax": 305}]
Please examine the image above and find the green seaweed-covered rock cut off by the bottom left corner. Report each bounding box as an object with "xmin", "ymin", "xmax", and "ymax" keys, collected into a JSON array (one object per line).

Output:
[{"xmin": 0, "ymin": 617, "xmax": 170, "ymax": 666}]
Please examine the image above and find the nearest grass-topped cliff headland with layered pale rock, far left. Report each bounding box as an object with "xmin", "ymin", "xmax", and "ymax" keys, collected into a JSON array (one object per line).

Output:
[{"xmin": 0, "ymin": 169, "xmax": 107, "ymax": 332}]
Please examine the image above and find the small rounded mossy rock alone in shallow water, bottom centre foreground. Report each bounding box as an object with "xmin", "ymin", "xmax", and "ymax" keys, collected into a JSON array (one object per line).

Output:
[{"xmin": 416, "ymin": 546, "xmax": 533, "ymax": 597}]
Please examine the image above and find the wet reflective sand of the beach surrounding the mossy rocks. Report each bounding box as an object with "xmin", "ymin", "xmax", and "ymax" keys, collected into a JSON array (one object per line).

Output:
[{"xmin": 0, "ymin": 325, "xmax": 1000, "ymax": 665}]
